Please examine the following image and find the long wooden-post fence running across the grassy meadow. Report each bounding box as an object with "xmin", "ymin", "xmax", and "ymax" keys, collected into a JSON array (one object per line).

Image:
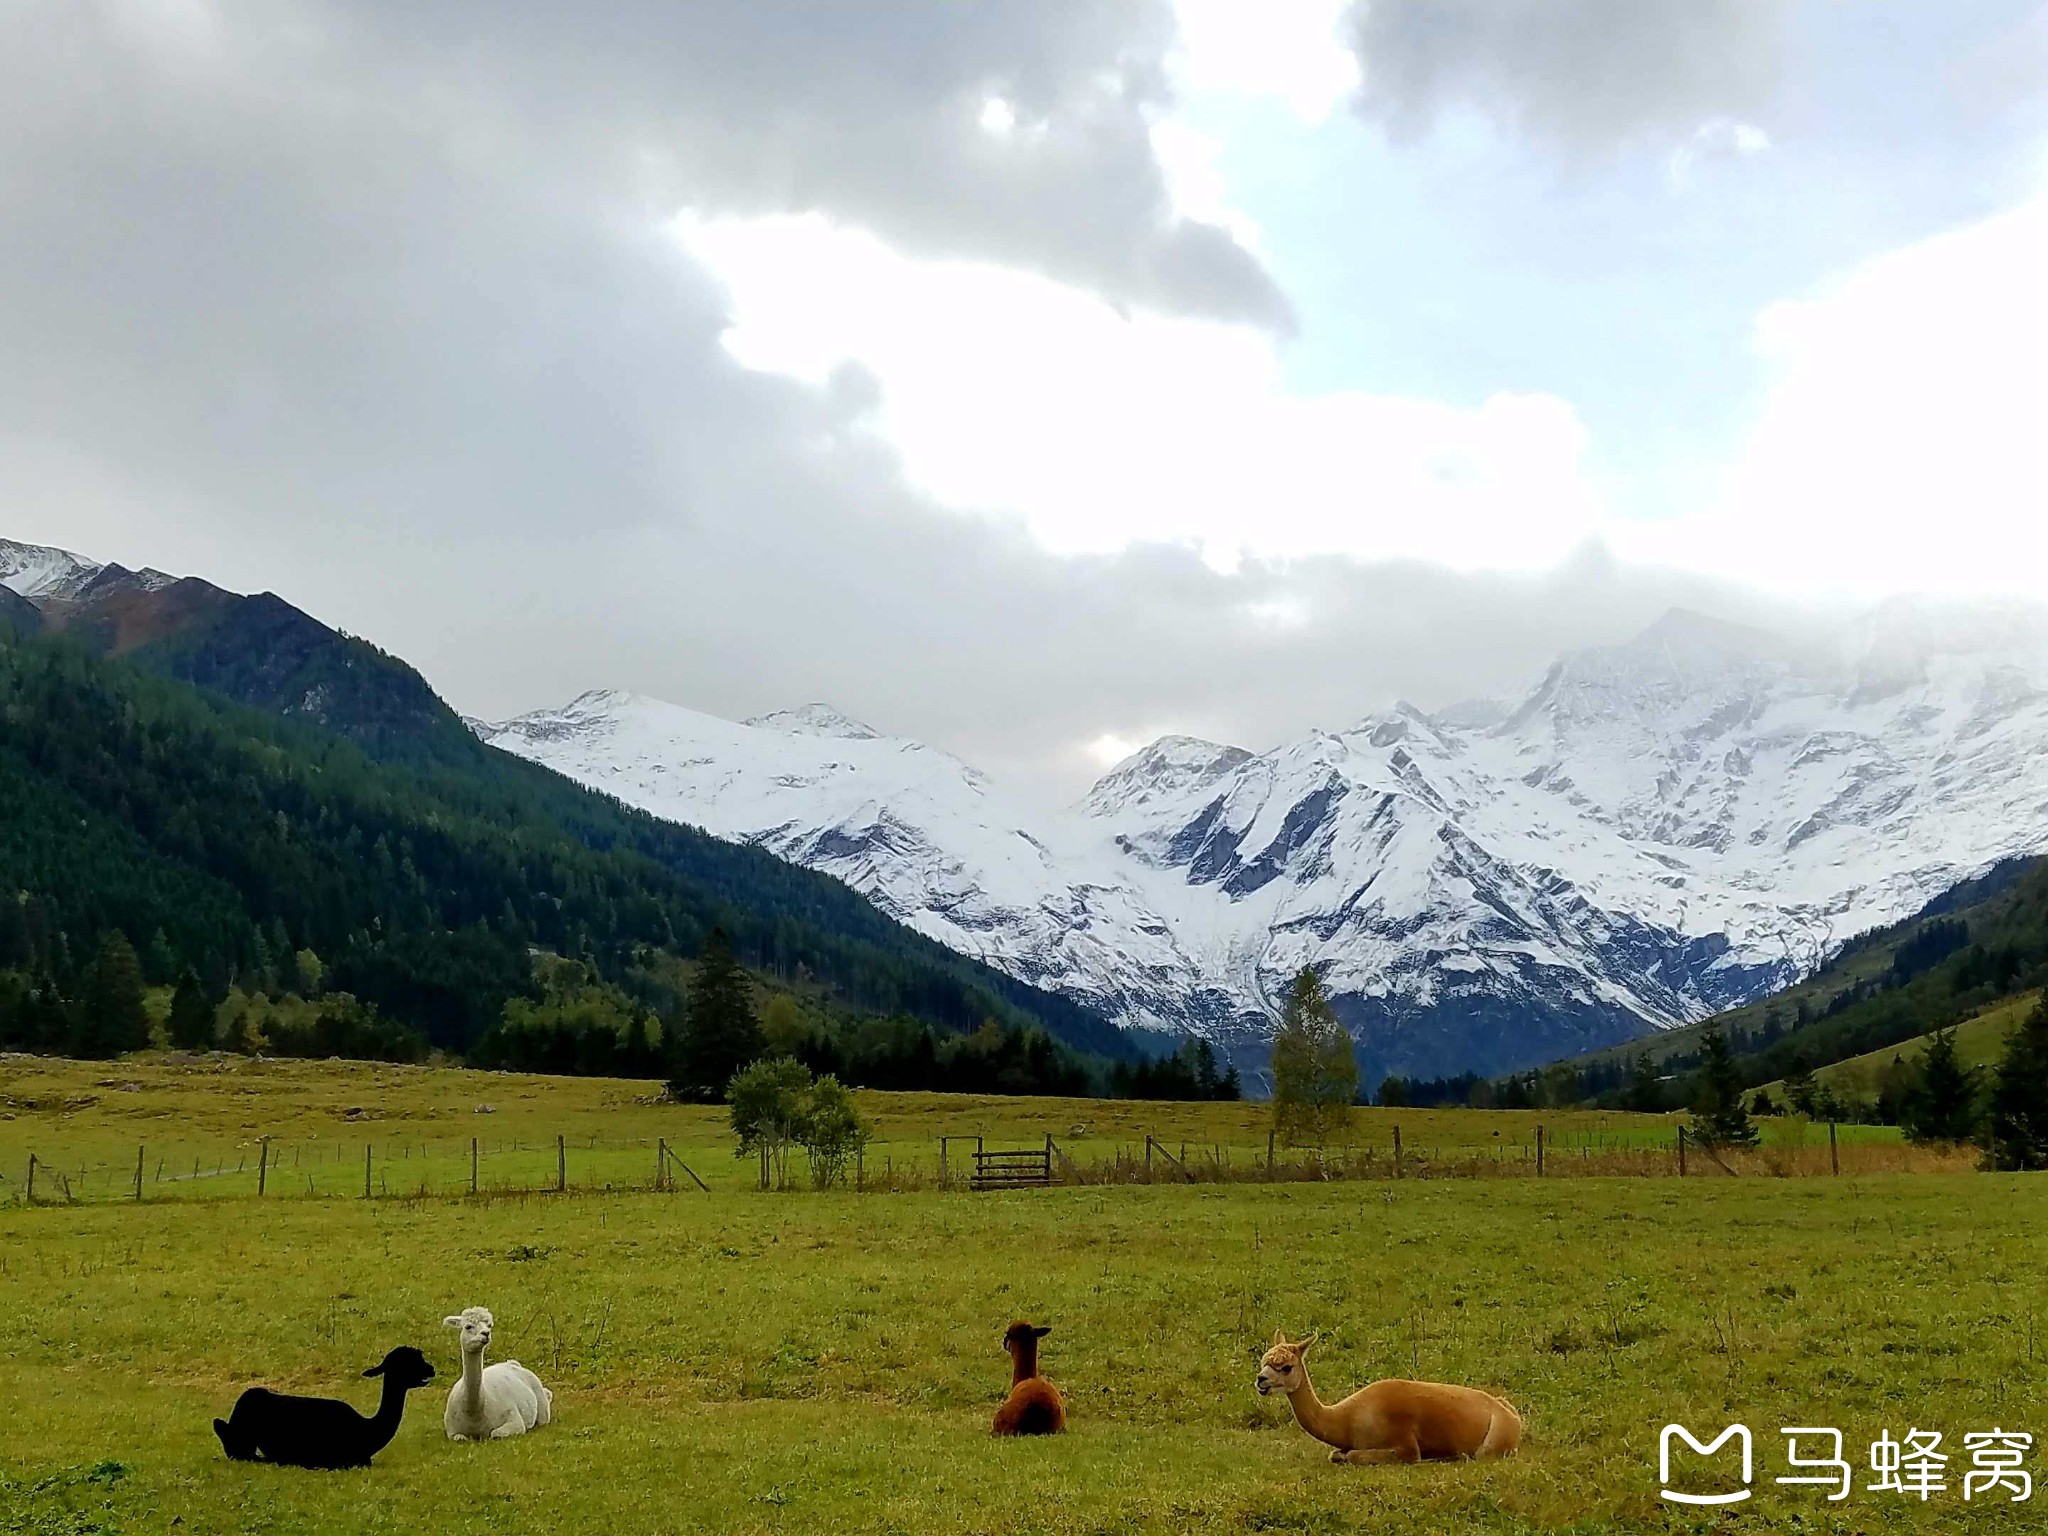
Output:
[{"xmin": 0, "ymin": 1124, "xmax": 1976, "ymax": 1206}]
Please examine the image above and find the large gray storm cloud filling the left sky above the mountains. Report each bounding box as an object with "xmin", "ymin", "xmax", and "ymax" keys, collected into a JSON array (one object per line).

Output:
[{"xmin": 0, "ymin": 0, "xmax": 1859, "ymax": 797}]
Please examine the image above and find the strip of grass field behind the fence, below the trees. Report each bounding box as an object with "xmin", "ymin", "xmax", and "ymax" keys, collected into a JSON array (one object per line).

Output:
[{"xmin": 0, "ymin": 1055, "xmax": 1905, "ymax": 1202}]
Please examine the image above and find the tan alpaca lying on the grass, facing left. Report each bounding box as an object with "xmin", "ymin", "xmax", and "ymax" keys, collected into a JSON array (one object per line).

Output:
[{"xmin": 1255, "ymin": 1331, "xmax": 1522, "ymax": 1466}]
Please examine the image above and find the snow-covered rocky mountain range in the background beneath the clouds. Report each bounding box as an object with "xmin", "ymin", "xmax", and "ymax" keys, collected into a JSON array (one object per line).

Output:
[{"xmin": 479, "ymin": 604, "xmax": 2048, "ymax": 1073}]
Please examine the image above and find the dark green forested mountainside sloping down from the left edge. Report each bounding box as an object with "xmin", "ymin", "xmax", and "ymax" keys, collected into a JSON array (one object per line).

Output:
[{"xmin": 0, "ymin": 626, "xmax": 1122, "ymax": 1055}]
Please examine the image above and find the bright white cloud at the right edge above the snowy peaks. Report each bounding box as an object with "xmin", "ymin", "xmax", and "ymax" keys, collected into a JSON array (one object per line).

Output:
[{"xmin": 1616, "ymin": 197, "xmax": 2048, "ymax": 596}]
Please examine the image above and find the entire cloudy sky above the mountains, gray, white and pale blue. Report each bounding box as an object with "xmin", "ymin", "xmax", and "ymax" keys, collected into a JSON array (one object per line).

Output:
[{"xmin": 0, "ymin": 0, "xmax": 2048, "ymax": 797}]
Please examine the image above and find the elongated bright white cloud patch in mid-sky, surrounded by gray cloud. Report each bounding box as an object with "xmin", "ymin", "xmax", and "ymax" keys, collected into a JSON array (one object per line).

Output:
[{"xmin": 674, "ymin": 215, "xmax": 1597, "ymax": 569}]
